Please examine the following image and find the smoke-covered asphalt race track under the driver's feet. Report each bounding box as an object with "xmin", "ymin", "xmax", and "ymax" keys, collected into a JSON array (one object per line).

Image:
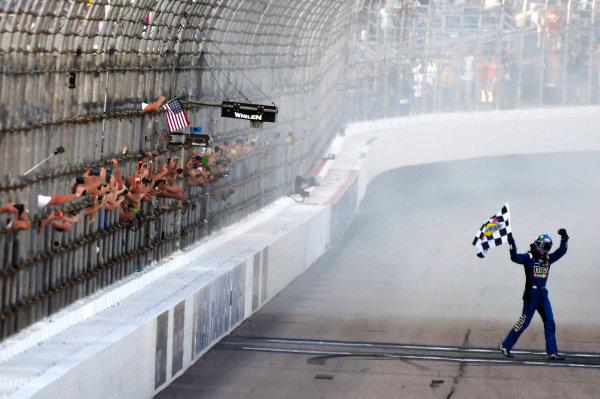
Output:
[{"xmin": 157, "ymin": 152, "xmax": 600, "ymax": 399}]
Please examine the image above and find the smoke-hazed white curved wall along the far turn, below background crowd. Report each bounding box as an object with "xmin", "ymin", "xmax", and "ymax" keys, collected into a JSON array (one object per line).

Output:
[{"xmin": 340, "ymin": 107, "xmax": 600, "ymax": 205}]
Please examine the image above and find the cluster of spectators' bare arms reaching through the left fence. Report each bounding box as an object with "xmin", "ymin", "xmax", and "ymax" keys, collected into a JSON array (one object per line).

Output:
[{"xmin": 0, "ymin": 125, "xmax": 293, "ymax": 242}]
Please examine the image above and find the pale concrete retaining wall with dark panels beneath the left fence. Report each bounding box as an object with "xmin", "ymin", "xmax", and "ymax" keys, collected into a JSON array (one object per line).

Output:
[{"xmin": 0, "ymin": 202, "xmax": 336, "ymax": 399}]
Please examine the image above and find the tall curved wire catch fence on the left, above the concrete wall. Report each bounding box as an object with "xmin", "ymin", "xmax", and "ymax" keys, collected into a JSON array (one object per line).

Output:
[{"xmin": 0, "ymin": 0, "xmax": 356, "ymax": 338}]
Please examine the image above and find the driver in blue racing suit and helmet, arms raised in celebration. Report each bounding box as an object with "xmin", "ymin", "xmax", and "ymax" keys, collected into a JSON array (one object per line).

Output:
[{"xmin": 500, "ymin": 229, "xmax": 569, "ymax": 360}]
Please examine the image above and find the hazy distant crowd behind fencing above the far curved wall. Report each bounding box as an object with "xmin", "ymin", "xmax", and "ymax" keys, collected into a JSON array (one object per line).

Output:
[{"xmin": 359, "ymin": 0, "xmax": 600, "ymax": 115}]
